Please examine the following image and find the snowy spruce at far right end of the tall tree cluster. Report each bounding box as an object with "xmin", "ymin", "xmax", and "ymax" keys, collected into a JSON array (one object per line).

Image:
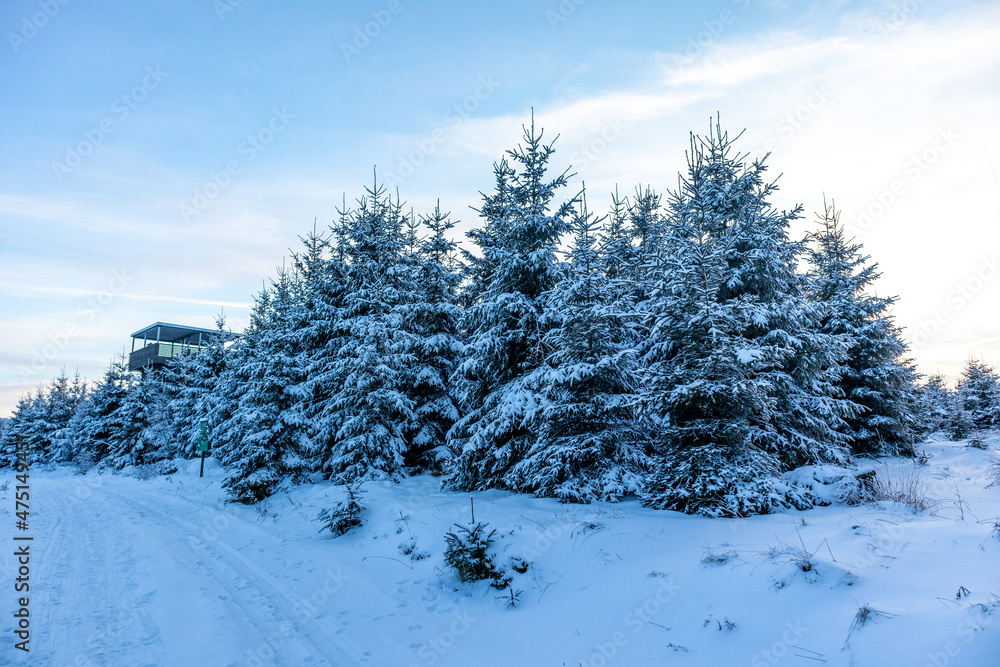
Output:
[{"xmin": 809, "ymin": 202, "xmax": 917, "ymax": 456}]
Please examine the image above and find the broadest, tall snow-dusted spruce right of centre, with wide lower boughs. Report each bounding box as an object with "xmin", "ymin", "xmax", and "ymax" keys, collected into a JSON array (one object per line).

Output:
[{"xmin": 641, "ymin": 123, "xmax": 853, "ymax": 516}]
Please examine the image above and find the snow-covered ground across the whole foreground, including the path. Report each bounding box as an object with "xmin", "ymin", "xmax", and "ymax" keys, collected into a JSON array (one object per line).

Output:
[{"xmin": 0, "ymin": 438, "xmax": 1000, "ymax": 667}]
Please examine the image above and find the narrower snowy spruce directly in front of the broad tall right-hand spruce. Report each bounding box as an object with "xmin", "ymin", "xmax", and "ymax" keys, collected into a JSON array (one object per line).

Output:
[{"xmin": 641, "ymin": 166, "xmax": 782, "ymax": 516}]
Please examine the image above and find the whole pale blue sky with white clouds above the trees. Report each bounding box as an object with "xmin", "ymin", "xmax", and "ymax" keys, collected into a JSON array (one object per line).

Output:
[{"xmin": 0, "ymin": 0, "xmax": 1000, "ymax": 415}]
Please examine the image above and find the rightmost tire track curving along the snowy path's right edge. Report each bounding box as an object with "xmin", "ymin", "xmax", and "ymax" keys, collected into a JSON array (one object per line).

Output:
[{"xmin": 99, "ymin": 488, "xmax": 362, "ymax": 667}]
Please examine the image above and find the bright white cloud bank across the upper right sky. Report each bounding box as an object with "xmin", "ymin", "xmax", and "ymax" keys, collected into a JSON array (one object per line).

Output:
[{"xmin": 376, "ymin": 6, "xmax": 1000, "ymax": 377}]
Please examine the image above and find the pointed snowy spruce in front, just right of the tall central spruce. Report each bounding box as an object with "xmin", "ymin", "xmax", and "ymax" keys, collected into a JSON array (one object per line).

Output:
[{"xmin": 506, "ymin": 193, "xmax": 648, "ymax": 502}]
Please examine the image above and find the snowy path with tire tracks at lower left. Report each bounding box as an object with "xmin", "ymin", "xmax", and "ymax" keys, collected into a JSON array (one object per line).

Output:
[{"xmin": 13, "ymin": 477, "xmax": 359, "ymax": 665}]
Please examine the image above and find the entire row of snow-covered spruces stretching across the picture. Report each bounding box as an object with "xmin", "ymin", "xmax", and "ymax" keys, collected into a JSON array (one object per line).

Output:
[{"xmin": 0, "ymin": 117, "xmax": 1000, "ymax": 517}]
